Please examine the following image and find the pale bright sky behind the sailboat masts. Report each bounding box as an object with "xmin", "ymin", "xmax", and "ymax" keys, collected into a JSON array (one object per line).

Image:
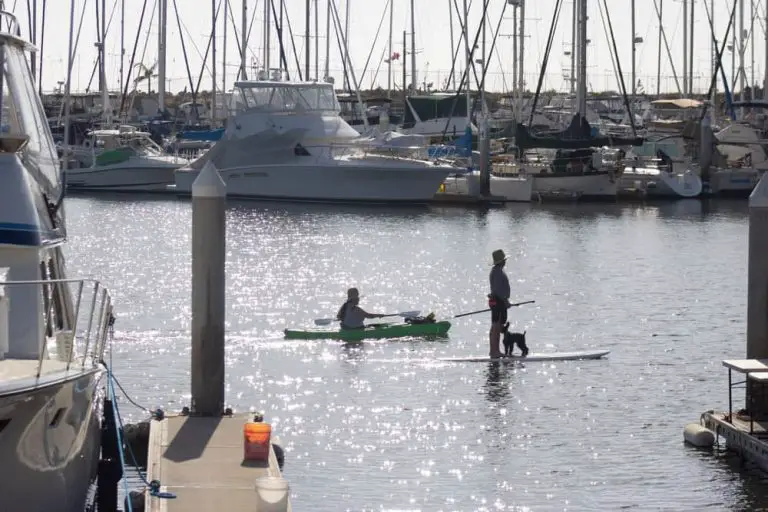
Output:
[{"xmin": 10, "ymin": 0, "xmax": 766, "ymax": 93}]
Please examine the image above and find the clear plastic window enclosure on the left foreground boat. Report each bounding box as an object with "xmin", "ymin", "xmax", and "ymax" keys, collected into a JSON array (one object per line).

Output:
[{"xmin": 0, "ymin": 44, "xmax": 59, "ymax": 191}]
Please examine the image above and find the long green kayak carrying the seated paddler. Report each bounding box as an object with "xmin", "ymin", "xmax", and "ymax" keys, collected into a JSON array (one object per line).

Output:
[{"xmin": 285, "ymin": 322, "xmax": 451, "ymax": 341}]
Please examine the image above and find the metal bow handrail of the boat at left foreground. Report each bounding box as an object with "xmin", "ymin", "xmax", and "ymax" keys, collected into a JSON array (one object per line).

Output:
[{"xmin": 0, "ymin": 278, "xmax": 114, "ymax": 379}]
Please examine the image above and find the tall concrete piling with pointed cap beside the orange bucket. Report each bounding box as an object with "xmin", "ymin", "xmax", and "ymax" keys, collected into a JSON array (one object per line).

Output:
[{"xmin": 191, "ymin": 161, "xmax": 227, "ymax": 416}]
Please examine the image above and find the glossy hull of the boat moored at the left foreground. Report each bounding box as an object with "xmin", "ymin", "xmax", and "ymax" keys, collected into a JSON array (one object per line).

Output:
[{"xmin": 0, "ymin": 369, "xmax": 104, "ymax": 512}]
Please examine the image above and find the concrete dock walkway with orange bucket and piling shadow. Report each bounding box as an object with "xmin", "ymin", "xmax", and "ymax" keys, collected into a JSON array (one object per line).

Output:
[{"xmin": 145, "ymin": 416, "xmax": 291, "ymax": 512}]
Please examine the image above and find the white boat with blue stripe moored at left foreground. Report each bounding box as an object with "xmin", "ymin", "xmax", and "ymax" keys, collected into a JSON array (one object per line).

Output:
[{"xmin": 0, "ymin": 12, "xmax": 112, "ymax": 512}]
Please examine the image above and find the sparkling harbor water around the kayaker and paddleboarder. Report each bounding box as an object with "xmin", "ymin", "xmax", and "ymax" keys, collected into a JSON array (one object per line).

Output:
[{"xmin": 66, "ymin": 196, "xmax": 768, "ymax": 511}]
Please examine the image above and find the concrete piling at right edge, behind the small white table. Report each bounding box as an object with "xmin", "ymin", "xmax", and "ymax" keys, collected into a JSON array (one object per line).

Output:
[{"xmin": 746, "ymin": 174, "xmax": 768, "ymax": 417}]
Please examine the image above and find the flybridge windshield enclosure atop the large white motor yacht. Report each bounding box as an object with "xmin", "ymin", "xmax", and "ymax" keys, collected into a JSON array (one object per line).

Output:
[{"xmin": 230, "ymin": 82, "xmax": 341, "ymax": 114}]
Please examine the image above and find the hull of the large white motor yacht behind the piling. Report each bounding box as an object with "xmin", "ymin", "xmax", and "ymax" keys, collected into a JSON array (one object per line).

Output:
[{"xmin": 175, "ymin": 161, "xmax": 456, "ymax": 203}]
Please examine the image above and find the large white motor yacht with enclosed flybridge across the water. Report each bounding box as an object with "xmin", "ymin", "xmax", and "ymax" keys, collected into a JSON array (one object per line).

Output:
[{"xmin": 175, "ymin": 80, "xmax": 456, "ymax": 203}]
